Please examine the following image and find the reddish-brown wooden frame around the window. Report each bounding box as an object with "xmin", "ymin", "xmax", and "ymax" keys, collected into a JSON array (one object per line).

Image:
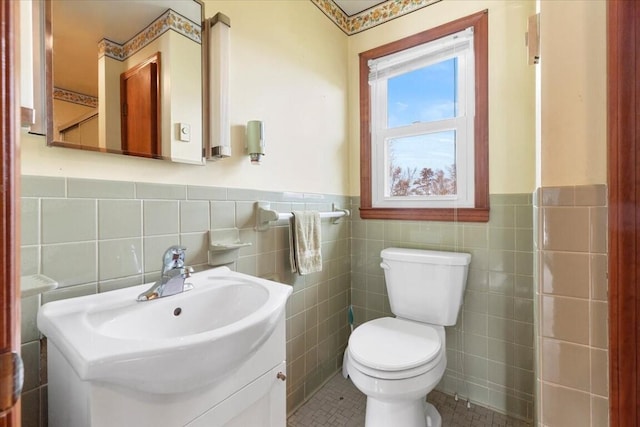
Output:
[{"xmin": 360, "ymin": 10, "xmax": 489, "ymax": 222}]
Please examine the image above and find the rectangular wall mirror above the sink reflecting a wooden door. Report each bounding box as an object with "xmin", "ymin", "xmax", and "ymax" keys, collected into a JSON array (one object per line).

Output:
[{"xmin": 44, "ymin": 0, "xmax": 203, "ymax": 164}]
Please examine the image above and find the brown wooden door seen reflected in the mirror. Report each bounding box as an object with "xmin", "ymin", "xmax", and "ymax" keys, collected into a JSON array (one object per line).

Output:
[{"xmin": 120, "ymin": 52, "xmax": 161, "ymax": 157}]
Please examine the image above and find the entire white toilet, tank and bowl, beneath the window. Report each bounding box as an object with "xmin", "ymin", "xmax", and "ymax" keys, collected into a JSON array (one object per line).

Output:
[{"xmin": 343, "ymin": 248, "xmax": 471, "ymax": 427}]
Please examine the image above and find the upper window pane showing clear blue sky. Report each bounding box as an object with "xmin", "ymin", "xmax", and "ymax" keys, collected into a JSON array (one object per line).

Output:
[{"xmin": 387, "ymin": 58, "xmax": 458, "ymax": 128}]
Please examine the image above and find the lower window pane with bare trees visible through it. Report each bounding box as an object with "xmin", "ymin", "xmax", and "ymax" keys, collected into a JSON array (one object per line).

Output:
[{"xmin": 386, "ymin": 130, "xmax": 457, "ymax": 197}]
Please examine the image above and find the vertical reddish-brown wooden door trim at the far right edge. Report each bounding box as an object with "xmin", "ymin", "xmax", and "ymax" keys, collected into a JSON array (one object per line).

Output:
[{"xmin": 607, "ymin": 0, "xmax": 640, "ymax": 427}]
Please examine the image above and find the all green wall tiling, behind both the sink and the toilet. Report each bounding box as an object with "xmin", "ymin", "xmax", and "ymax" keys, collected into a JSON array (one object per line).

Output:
[{"xmin": 22, "ymin": 176, "xmax": 533, "ymax": 426}]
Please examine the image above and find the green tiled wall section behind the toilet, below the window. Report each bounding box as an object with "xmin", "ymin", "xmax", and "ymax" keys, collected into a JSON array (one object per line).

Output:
[{"xmin": 351, "ymin": 194, "xmax": 534, "ymax": 420}]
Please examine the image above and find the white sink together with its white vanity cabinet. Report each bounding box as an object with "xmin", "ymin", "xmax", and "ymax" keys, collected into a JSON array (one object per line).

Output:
[{"xmin": 38, "ymin": 267, "xmax": 291, "ymax": 427}]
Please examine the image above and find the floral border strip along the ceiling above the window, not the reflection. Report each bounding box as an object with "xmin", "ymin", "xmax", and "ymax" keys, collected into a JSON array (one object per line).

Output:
[{"xmin": 311, "ymin": 0, "xmax": 441, "ymax": 36}]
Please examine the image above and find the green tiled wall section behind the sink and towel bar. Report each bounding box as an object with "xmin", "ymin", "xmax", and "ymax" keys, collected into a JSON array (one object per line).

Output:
[{"xmin": 21, "ymin": 176, "xmax": 350, "ymax": 427}]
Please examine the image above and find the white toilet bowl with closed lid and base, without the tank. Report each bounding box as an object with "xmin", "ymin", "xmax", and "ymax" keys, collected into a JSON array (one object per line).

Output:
[{"xmin": 345, "ymin": 317, "xmax": 447, "ymax": 427}]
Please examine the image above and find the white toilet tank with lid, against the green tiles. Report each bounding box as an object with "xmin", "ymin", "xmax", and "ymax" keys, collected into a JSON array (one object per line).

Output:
[{"xmin": 380, "ymin": 248, "xmax": 471, "ymax": 326}]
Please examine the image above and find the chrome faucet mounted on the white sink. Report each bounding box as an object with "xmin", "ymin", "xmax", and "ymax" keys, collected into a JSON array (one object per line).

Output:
[{"xmin": 138, "ymin": 246, "xmax": 193, "ymax": 301}]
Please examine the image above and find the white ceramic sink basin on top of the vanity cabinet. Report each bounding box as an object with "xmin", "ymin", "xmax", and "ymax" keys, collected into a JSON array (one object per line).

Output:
[{"xmin": 38, "ymin": 267, "xmax": 291, "ymax": 394}]
